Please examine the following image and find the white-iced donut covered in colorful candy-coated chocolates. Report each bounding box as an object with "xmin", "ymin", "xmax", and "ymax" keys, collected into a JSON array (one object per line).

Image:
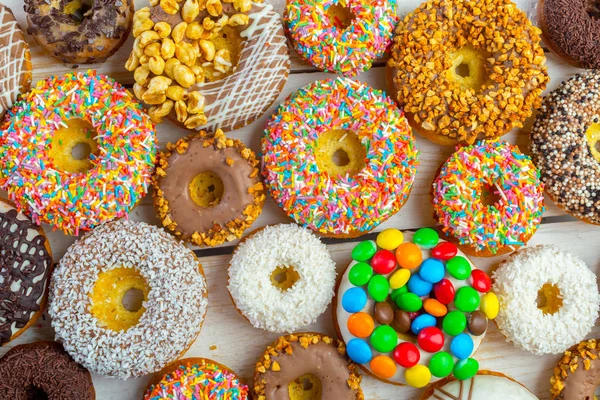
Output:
[{"xmin": 333, "ymin": 228, "xmax": 498, "ymax": 388}]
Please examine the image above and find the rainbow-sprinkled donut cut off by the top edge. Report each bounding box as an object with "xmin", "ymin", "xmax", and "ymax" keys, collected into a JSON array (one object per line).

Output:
[{"xmin": 283, "ymin": 0, "xmax": 399, "ymax": 77}]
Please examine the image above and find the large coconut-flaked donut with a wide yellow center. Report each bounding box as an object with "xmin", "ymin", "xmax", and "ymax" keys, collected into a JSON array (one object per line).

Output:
[{"xmin": 48, "ymin": 220, "xmax": 207, "ymax": 379}]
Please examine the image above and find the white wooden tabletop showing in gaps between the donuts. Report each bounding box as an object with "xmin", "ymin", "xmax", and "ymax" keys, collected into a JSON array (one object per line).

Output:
[{"xmin": 0, "ymin": 0, "xmax": 600, "ymax": 400}]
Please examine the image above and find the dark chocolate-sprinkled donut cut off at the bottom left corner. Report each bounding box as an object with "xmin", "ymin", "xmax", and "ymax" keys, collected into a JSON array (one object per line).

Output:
[{"xmin": 0, "ymin": 342, "xmax": 96, "ymax": 400}]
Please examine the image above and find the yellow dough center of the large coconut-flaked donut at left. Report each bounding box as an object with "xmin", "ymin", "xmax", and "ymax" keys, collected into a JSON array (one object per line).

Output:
[{"xmin": 90, "ymin": 267, "xmax": 150, "ymax": 331}]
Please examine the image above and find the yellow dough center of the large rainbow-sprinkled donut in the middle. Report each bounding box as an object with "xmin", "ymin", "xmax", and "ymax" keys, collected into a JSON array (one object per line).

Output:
[{"xmin": 315, "ymin": 129, "xmax": 366, "ymax": 176}]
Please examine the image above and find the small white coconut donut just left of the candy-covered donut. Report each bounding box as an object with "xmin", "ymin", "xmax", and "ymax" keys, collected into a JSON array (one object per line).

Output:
[{"xmin": 227, "ymin": 224, "xmax": 336, "ymax": 333}]
